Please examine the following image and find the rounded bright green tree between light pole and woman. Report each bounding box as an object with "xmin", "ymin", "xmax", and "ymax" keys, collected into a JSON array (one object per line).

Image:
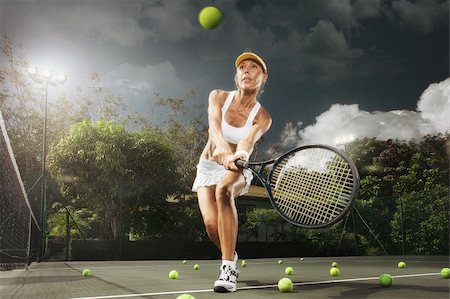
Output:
[{"xmin": 48, "ymin": 120, "xmax": 178, "ymax": 239}]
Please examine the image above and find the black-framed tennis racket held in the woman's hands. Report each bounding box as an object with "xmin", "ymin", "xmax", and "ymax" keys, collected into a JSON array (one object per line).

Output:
[{"xmin": 236, "ymin": 145, "xmax": 359, "ymax": 228}]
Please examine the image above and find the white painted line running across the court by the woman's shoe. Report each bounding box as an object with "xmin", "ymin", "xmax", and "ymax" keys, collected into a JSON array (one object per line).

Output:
[{"xmin": 71, "ymin": 273, "xmax": 440, "ymax": 299}]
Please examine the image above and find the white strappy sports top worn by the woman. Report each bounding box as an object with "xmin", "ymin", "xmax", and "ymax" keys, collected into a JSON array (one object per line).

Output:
[{"xmin": 222, "ymin": 90, "xmax": 261, "ymax": 144}]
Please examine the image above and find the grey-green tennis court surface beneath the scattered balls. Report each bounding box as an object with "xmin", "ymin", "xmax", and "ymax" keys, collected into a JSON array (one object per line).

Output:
[{"xmin": 0, "ymin": 256, "xmax": 450, "ymax": 299}]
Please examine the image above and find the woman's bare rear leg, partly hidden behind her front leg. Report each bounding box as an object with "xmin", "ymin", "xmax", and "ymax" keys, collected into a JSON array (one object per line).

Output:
[{"xmin": 197, "ymin": 186, "xmax": 221, "ymax": 250}]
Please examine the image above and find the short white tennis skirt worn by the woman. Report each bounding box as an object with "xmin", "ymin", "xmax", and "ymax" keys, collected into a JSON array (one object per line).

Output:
[{"xmin": 192, "ymin": 159, "xmax": 253, "ymax": 195}]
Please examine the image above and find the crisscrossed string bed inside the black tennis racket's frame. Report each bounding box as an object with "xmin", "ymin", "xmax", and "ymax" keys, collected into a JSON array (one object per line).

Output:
[{"xmin": 271, "ymin": 148, "xmax": 354, "ymax": 225}]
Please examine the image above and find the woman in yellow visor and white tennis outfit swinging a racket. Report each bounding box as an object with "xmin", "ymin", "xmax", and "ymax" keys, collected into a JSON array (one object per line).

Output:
[{"xmin": 192, "ymin": 52, "xmax": 272, "ymax": 292}]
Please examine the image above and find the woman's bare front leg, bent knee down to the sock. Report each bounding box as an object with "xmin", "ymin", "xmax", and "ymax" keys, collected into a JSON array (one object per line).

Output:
[{"xmin": 215, "ymin": 172, "xmax": 246, "ymax": 261}]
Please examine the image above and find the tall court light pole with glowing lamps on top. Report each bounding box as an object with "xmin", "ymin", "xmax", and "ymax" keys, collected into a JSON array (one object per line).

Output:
[{"xmin": 28, "ymin": 66, "xmax": 67, "ymax": 261}]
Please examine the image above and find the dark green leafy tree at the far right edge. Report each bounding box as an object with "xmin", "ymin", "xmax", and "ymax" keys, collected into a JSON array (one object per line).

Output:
[{"xmin": 391, "ymin": 134, "xmax": 450, "ymax": 254}]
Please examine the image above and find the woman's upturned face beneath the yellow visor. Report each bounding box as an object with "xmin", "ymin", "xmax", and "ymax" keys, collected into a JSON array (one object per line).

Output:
[{"xmin": 235, "ymin": 59, "xmax": 267, "ymax": 90}]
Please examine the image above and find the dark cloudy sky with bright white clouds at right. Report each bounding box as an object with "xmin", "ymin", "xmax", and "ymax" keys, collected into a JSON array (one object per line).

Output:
[{"xmin": 0, "ymin": 0, "xmax": 450, "ymax": 152}]
